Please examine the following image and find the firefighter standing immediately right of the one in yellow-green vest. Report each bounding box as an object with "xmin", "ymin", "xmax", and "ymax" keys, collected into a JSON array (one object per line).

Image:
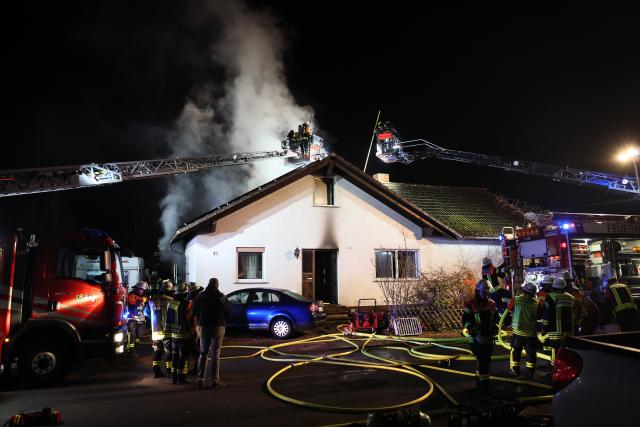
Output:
[{"xmin": 542, "ymin": 277, "xmax": 574, "ymax": 364}]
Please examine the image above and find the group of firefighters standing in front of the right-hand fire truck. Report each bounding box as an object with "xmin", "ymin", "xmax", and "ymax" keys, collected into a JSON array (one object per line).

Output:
[{"xmin": 462, "ymin": 258, "xmax": 640, "ymax": 388}]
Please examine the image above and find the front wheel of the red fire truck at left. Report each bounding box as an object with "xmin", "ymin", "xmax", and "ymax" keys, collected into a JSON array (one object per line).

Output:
[{"xmin": 18, "ymin": 340, "xmax": 70, "ymax": 386}]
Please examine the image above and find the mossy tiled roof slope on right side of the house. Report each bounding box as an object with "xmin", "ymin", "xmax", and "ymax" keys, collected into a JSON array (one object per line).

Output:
[{"xmin": 385, "ymin": 182, "xmax": 525, "ymax": 239}]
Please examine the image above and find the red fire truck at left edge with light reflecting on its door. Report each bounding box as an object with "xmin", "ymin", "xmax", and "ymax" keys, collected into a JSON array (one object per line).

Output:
[{"xmin": 0, "ymin": 229, "xmax": 127, "ymax": 385}]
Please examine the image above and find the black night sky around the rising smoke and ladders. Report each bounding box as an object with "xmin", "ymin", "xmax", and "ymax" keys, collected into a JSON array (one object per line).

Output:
[{"xmin": 0, "ymin": 1, "xmax": 640, "ymax": 272}]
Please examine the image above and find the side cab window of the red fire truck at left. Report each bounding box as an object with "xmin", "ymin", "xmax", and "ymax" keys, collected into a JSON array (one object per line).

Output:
[{"xmin": 56, "ymin": 248, "xmax": 107, "ymax": 282}]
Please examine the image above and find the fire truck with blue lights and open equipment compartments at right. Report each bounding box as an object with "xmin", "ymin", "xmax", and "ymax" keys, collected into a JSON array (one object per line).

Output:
[{"xmin": 501, "ymin": 212, "xmax": 640, "ymax": 300}]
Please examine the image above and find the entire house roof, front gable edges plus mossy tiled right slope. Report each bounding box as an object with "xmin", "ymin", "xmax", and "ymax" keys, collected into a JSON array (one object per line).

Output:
[{"xmin": 171, "ymin": 153, "xmax": 523, "ymax": 243}]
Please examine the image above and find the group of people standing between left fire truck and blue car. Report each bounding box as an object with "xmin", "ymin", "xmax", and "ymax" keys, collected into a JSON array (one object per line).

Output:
[{"xmin": 122, "ymin": 279, "xmax": 230, "ymax": 388}]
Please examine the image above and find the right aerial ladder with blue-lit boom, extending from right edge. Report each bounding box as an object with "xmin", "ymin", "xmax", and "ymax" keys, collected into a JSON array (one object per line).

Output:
[{"xmin": 375, "ymin": 122, "xmax": 640, "ymax": 196}]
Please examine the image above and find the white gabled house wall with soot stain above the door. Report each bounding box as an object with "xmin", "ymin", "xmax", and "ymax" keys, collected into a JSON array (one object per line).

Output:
[{"xmin": 186, "ymin": 176, "xmax": 499, "ymax": 305}]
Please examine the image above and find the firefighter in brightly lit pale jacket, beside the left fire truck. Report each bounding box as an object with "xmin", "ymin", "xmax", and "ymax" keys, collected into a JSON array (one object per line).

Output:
[{"xmin": 149, "ymin": 279, "xmax": 173, "ymax": 378}]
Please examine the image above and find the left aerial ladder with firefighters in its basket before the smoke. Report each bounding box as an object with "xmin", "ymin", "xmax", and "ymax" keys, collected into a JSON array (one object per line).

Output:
[{"xmin": 0, "ymin": 123, "xmax": 326, "ymax": 197}]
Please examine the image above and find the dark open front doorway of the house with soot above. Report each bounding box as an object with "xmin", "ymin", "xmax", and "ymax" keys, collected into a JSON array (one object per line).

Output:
[{"xmin": 302, "ymin": 249, "xmax": 338, "ymax": 304}]
